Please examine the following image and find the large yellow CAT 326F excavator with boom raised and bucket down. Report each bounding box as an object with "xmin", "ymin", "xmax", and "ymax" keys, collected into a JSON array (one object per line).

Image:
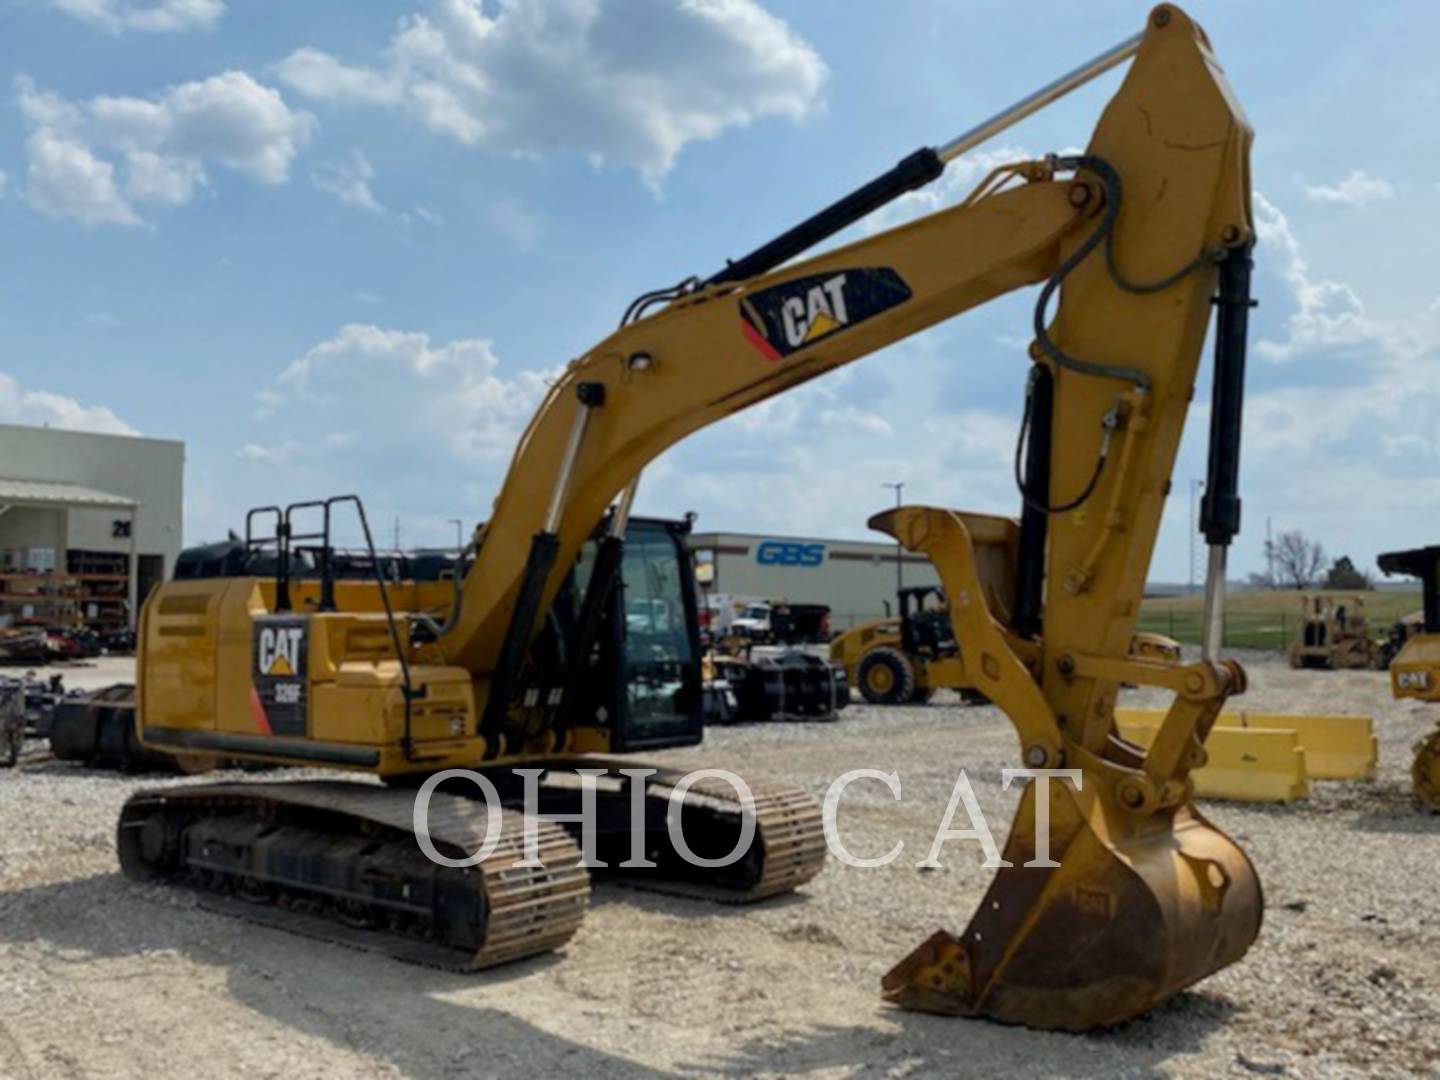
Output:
[{"xmin": 118, "ymin": 4, "xmax": 1261, "ymax": 1030}]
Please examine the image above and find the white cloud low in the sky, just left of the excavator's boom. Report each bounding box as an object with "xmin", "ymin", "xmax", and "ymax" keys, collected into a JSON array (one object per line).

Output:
[{"xmin": 258, "ymin": 323, "xmax": 557, "ymax": 464}]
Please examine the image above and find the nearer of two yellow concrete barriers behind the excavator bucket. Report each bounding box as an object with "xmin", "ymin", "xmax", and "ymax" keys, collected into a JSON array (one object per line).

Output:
[{"xmin": 1116, "ymin": 720, "xmax": 1310, "ymax": 802}]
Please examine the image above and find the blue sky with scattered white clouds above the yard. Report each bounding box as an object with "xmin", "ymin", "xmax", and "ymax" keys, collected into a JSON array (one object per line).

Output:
[{"xmin": 0, "ymin": 0, "xmax": 1440, "ymax": 580}]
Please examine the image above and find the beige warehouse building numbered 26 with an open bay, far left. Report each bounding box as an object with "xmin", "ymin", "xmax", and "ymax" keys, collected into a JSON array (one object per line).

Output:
[{"xmin": 0, "ymin": 423, "xmax": 184, "ymax": 631}]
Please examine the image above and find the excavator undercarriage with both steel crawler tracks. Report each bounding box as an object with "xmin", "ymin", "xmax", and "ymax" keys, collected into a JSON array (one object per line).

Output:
[{"xmin": 118, "ymin": 757, "xmax": 825, "ymax": 971}]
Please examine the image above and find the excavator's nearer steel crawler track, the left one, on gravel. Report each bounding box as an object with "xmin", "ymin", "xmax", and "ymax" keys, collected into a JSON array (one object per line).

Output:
[{"xmin": 117, "ymin": 780, "xmax": 590, "ymax": 971}]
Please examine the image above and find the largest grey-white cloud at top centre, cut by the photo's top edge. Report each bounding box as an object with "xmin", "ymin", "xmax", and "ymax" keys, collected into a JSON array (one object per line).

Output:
[{"xmin": 278, "ymin": 0, "xmax": 827, "ymax": 183}]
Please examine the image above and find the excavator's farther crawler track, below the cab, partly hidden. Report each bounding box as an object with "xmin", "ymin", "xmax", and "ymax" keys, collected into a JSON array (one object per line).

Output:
[{"xmin": 506, "ymin": 757, "xmax": 827, "ymax": 904}]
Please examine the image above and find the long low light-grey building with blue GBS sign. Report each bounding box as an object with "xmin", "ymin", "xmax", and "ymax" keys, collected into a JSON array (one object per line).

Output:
[{"xmin": 690, "ymin": 533, "xmax": 940, "ymax": 631}]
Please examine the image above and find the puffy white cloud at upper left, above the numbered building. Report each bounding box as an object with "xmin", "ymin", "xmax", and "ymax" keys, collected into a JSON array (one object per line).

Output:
[{"xmin": 14, "ymin": 71, "xmax": 314, "ymax": 225}]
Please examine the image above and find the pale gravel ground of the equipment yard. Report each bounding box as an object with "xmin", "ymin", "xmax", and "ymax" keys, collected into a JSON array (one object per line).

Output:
[{"xmin": 0, "ymin": 655, "xmax": 1440, "ymax": 1077}]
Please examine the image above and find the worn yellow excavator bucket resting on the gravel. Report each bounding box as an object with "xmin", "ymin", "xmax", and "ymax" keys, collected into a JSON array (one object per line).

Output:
[{"xmin": 883, "ymin": 773, "xmax": 1263, "ymax": 1031}]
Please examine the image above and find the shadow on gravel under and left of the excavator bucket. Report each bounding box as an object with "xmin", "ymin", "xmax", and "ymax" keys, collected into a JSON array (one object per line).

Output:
[{"xmin": 681, "ymin": 986, "xmax": 1240, "ymax": 1077}]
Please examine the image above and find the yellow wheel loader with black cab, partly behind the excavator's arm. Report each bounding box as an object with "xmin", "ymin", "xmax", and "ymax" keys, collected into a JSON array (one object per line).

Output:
[{"xmin": 829, "ymin": 584, "xmax": 1181, "ymax": 706}]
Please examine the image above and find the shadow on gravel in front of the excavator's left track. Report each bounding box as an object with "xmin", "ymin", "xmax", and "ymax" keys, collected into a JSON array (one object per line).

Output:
[{"xmin": 0, "ymin": 873, "xmax": 665, "ymax": 1080}]
